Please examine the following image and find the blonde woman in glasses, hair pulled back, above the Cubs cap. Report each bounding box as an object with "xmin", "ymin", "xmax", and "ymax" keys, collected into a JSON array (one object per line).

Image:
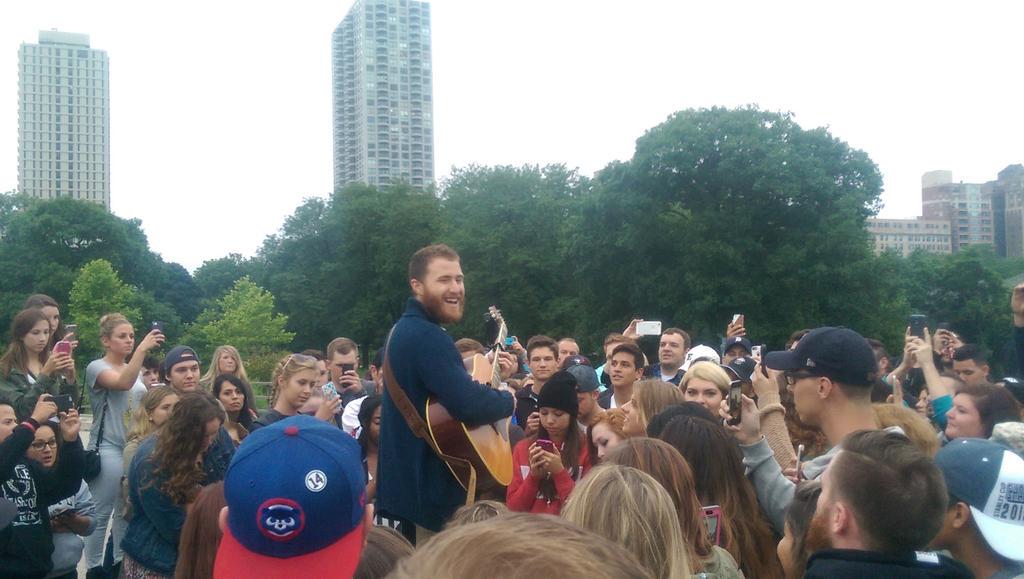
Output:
[{"xmin": 252, "ymin": 354, "xmax": 341, "ymax": 430}]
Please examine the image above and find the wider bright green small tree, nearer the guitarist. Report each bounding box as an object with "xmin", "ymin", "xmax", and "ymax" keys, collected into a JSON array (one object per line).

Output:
[{"xmin": 185, "ymin": 278, "xmax": 295, "ymax": 359}]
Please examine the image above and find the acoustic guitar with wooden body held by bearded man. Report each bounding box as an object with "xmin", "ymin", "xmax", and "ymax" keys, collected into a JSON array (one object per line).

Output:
[{"xmin": 426, "ymin": 305, "xmax": 512, "ymax": 494}]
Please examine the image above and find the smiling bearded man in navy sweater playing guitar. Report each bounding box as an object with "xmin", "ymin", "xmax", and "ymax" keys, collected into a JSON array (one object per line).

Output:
[{"xmin": 377, "ymin": 245, "xmax": 516, "ymax": 542}]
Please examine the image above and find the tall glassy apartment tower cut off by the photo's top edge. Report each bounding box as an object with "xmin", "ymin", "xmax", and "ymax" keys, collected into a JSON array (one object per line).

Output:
[{"xmin": 331, "ymin": 0, "xmax": 434, "ymax": 190}]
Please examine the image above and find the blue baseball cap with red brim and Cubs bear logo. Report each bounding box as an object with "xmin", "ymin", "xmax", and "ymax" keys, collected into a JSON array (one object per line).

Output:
[{"xmin": 213, "ymin": 415, "xmax": 367, "ymax": 579}]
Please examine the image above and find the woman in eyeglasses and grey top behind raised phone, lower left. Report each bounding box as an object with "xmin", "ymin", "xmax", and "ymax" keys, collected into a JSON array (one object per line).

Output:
[{"xmin": 25, "ymin": 422, "xmax": 96, "ymax": 579}]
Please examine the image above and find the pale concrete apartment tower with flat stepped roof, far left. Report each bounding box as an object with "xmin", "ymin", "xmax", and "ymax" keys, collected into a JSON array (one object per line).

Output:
[{"xmin": 17, "ymin": 31, "xmax": 111, "ymax": 209}]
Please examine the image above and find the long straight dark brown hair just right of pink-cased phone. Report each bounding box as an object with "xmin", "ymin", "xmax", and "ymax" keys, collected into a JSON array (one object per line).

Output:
[{"xmin": 659, "ymin": 416, "xmax": 782, "ymax": 578}]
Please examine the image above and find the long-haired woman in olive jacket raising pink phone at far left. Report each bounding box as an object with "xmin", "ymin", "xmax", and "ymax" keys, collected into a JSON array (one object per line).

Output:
[{"xmin": 0, "ymin": 309, "xmax": 76, "ymax": 418}]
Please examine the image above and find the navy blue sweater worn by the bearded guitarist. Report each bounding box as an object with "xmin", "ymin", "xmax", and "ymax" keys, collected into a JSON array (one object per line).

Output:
[{"xmin": 377, "ymin": 299, "xmax": 513, "ymax": 531}]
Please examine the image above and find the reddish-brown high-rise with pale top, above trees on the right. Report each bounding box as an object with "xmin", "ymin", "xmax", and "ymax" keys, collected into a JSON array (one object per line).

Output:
[{"xmin": 921, "ymin": 171, "xmax": 995, "ymax": 253}]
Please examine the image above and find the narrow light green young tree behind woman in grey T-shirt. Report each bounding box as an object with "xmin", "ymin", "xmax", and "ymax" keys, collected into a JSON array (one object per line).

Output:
[{"xmin": 68, "ymin": 259, "xmax": 140, "ymax": 363}]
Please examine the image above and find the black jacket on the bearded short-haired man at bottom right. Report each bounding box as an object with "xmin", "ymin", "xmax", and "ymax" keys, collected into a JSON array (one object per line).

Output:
[{"xmin": 804, "ymin": 549, "xmax": 973, "ymax": 579}]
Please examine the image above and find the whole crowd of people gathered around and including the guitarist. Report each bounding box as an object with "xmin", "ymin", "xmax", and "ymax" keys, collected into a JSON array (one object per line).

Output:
[{"xmin": 0, "ymin": 245, "xmax": 1024, "ymax": 579}]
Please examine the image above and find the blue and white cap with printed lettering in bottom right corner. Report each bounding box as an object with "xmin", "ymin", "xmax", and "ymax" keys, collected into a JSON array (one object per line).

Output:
[{"xmin": 935, "ymin": 439, "xmax": 1024, "ymax": 561}]
